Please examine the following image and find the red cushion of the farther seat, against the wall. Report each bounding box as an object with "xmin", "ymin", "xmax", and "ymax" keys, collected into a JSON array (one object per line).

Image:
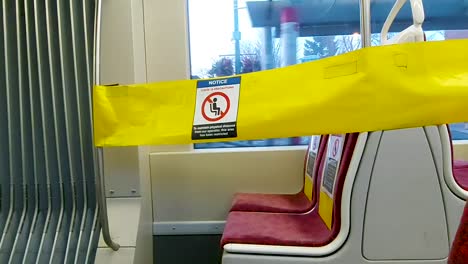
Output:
[{"xmin": 231, "ymin": 191, "xmax": 312, "ymax": 213}]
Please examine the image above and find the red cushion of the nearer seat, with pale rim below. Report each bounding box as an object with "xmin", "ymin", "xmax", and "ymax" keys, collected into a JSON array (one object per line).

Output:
[{"xmin": 221, "ymin": 210, "xmax": 333, "ymax": 247}]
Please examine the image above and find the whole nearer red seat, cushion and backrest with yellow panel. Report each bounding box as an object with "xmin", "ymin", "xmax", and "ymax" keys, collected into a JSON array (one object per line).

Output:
[{"xmin": 221, "ymin": 133, "xmax": 359, "ymax": 247}]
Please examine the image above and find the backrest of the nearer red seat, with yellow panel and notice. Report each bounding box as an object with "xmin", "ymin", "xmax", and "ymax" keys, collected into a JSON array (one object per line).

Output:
[{"xmin": 316, "ymin": 133, "xmax": 359, "ymax": 230}]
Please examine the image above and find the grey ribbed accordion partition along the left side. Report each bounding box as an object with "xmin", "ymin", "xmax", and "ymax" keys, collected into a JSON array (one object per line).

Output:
[{"xmin": 0, "ymin": 0, "xmax": 100, "ymax": 263}]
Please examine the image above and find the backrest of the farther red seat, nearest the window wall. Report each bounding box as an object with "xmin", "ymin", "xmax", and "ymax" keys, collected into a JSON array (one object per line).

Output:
[{"xmin": 303, "ymin": 135, "xmax": 328, "ymax": 204}]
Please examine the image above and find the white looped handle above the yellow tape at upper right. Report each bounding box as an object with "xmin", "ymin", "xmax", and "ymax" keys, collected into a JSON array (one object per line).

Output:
[{"xmin": 380, "ymin": 0, "xmax": 425, "ymax": 45}]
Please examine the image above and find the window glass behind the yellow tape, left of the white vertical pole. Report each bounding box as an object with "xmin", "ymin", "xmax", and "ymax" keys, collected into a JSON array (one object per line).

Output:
[{"xmin": 188, "ymin": 0, "xmax": 360, "ymax": 148}]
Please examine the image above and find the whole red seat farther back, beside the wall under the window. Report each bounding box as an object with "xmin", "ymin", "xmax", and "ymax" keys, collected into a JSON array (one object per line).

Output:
[{"xmin": 230, "ymin": 136, "xmax": 328, "ymax": 213}]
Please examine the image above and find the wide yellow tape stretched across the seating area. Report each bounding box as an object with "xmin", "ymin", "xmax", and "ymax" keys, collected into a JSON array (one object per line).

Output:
[{"xmin": 94, "ymin": 40, "xmax": 468, "ymax": 146}]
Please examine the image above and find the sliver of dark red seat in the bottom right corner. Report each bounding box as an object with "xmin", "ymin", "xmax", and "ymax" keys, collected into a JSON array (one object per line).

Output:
[{"xmin": 448, "ymin": 202, "xmax": 468, "ymax": 264}]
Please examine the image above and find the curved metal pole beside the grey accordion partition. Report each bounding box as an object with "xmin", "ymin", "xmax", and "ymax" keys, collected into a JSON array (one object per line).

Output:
[{"xmin": 91, "ymin": 0, "xmax": 120, "ymax": 251}]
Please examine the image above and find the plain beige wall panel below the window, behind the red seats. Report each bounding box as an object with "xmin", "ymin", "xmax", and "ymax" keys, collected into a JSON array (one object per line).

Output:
[{"xmin": 150, "ymin": 147, "xmax": 306, "ymax": 223}]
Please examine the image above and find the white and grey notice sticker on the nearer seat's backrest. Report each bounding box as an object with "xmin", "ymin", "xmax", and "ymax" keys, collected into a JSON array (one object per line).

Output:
[{"xmin": 322, "ymin": 135, "xmax": 344, "ymax": 198}]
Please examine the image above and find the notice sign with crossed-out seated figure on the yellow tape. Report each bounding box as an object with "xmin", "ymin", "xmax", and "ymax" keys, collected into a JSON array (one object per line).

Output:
[{"xmin": 192, "ymin": 77, "xmax": 241, "ymax": 140}]
